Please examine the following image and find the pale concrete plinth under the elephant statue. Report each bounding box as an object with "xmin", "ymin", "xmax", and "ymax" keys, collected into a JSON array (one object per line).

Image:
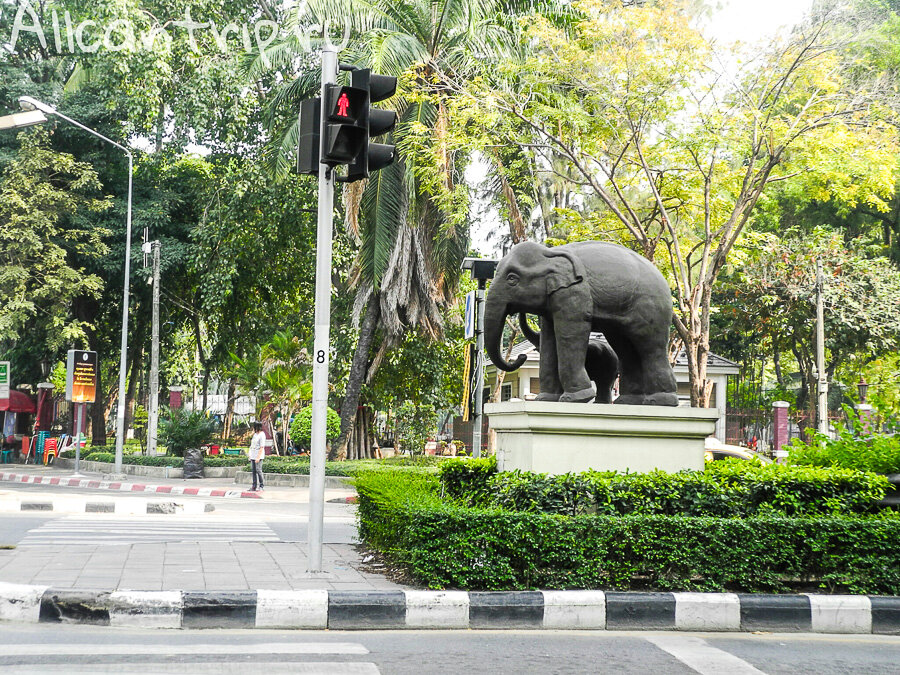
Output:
[{"xmin": 485, "ymin": 401, "xmax": 719, "ymax": 474}]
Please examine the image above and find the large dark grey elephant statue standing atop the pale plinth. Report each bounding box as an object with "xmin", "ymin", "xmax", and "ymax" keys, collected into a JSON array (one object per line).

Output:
[{"xmin": 484, "ymin": 241, "xmax": 678, "ymax": 406}]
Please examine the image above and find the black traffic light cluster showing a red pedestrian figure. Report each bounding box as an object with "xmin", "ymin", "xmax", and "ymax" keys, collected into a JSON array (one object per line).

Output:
[{"xmin": 297, "ymin": 66, "xmax": 397, "ymax": 183}]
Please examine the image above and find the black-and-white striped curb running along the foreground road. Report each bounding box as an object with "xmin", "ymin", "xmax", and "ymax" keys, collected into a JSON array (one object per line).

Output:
[{"xmin": 0, "ymin": 583, "xmax": 900, "ymax": 635}]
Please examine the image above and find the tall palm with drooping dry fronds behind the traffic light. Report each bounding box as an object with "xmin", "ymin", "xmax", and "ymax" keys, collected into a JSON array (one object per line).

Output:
[{"xmin": 249, "ymin": 0, "xmax": 562, "ymax": 455}]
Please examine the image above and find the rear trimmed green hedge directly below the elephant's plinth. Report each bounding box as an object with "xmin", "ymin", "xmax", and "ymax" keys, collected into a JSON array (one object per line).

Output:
[{"xmin": 441, "ymin": 460, "xmax": 888, "ymax": 518}]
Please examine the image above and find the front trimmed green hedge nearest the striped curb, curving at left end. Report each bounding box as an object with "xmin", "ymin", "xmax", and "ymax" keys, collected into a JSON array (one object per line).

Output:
[{"xmin": 356, "ymin": 473, "xmax": 900, "ymax": 595}]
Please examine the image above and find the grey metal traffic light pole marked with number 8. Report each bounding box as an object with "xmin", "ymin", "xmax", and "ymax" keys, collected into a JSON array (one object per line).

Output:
[{"xmin": 309, "ymin": 46, "xmax": 338, "ymax": 572}]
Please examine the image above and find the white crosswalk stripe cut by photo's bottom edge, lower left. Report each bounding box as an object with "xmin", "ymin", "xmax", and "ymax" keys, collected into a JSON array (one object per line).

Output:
[{"xmin": 0, "ymin": 661, "xmax": 381, "ymax": 675}]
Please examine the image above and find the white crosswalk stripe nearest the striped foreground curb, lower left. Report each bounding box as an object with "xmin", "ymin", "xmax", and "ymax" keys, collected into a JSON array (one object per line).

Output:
[{"xmin": 2, "ymin": 642, "xmax": 369, "ymax": 656}]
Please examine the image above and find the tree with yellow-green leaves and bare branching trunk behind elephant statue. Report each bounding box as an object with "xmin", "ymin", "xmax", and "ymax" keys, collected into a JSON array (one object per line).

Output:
[{"xmin": 454, "ymin": 0, "xmax": 897, "ymax": 406}]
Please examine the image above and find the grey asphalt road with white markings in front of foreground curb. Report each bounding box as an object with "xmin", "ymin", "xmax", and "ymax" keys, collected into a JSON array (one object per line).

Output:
[{"xmin": 0, "ymin": 624, "xmax": 900, "ymax": 675}]
